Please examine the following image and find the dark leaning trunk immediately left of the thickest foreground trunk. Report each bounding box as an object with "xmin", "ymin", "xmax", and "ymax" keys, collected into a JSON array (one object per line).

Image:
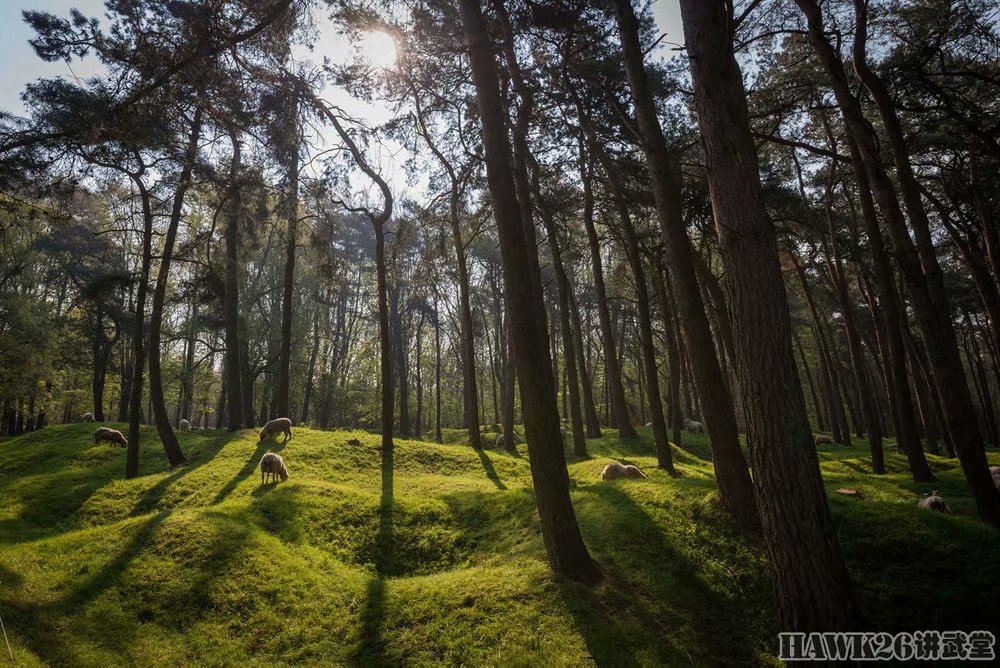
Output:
[{"xmin": 614, "ymin": 0, "xmax": 760, "ymax": 532}]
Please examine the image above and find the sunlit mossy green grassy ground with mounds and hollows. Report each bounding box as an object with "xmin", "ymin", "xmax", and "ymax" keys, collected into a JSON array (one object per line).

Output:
[{"xmin": 0, "ymin": 425, "xmax": 1000, "ymax": 665}]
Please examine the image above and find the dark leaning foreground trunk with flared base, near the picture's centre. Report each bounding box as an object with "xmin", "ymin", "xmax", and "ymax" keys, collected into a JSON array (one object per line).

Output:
[{"xmin": 459, "ymin": 0, "xmax": 601, "ymax": 582}]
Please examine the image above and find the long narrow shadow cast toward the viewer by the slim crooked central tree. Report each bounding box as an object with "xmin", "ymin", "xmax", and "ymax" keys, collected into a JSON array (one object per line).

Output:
[{"xmin": 352, "ymin": 450, "xmax": 394, "ymax": 666}]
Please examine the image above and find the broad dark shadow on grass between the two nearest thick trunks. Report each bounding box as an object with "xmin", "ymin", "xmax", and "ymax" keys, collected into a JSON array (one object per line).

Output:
[{"xmin": 560, "ymin": 484, "xmax": 773, "ymax": 666}]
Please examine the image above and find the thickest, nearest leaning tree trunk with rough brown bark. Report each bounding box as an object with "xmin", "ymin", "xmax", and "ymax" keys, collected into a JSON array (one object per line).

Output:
[{"xmin": 680, "ymin": 0, "xmax": 860, "ymax": 632}]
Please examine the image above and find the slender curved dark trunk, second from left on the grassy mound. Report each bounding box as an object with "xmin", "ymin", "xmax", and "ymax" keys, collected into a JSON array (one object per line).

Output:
[{"xmin": 149, "ymin": 107, "xmax": 202, "ymax": 466}]
